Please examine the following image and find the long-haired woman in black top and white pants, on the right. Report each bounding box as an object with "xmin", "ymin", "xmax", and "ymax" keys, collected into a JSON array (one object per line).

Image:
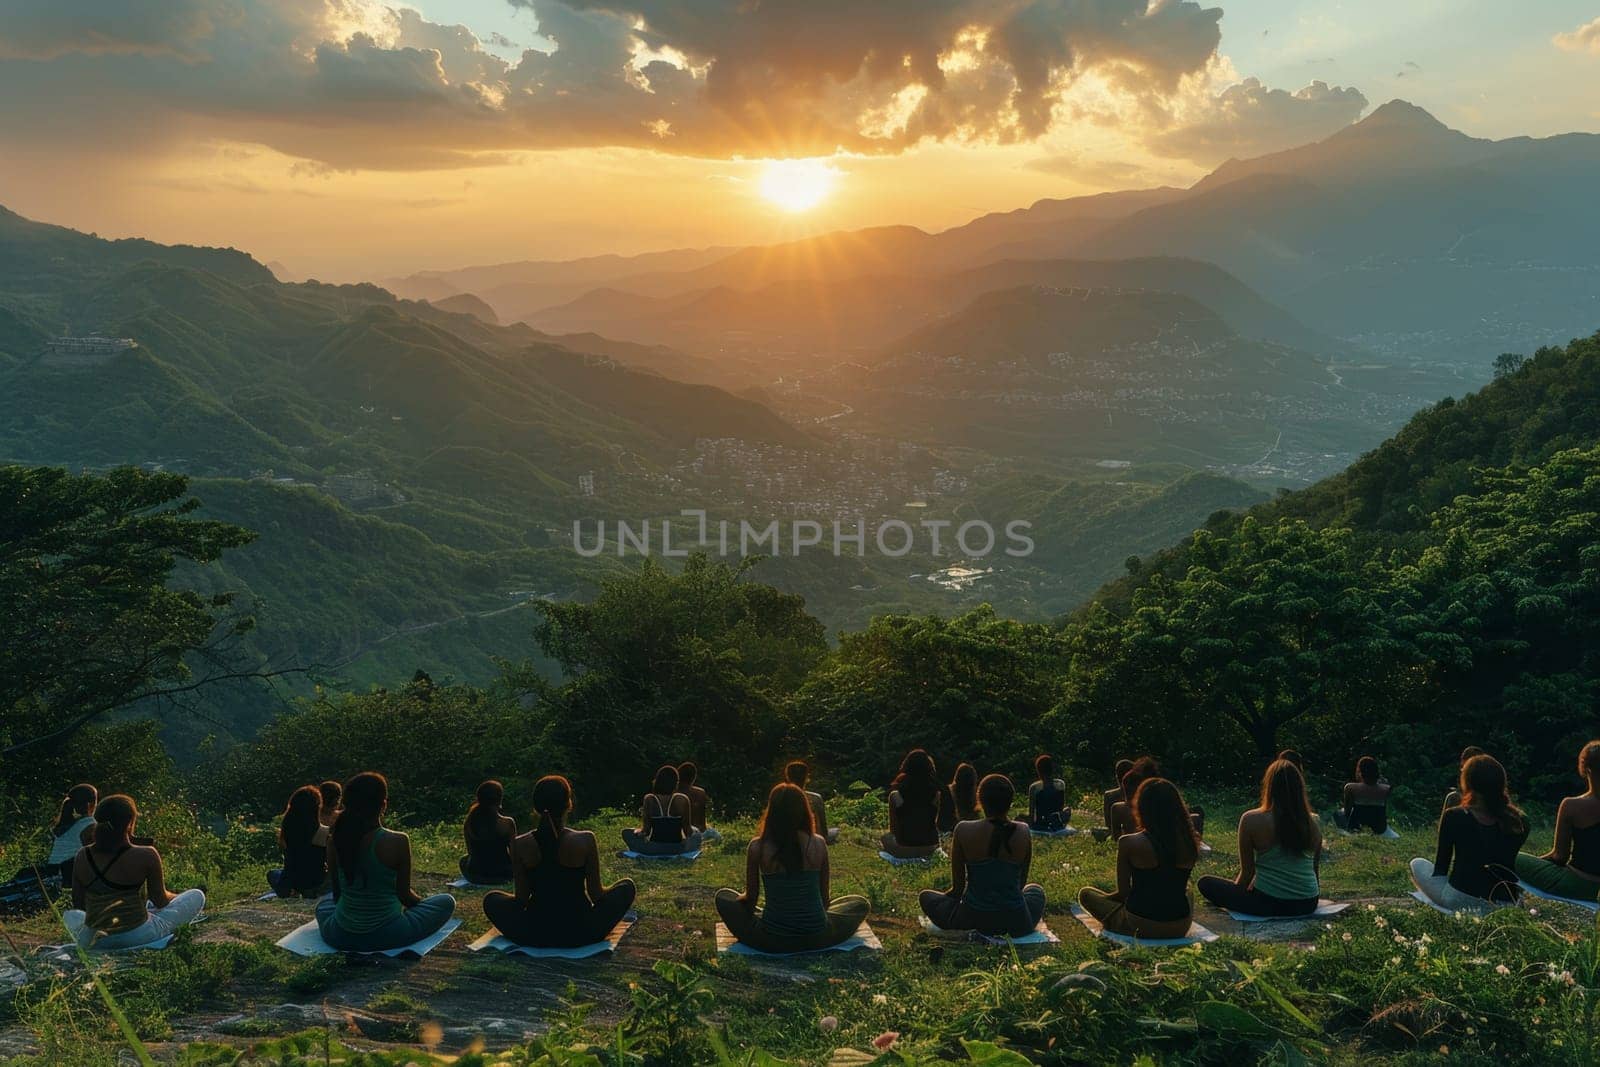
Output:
[{"xmin": 1411, "ymin": 755, "xmax": 1528, "ymax": 912}]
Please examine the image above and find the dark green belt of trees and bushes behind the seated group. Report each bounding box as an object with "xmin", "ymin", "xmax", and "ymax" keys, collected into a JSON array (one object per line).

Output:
[{"xmin": 0, "ymin": 338, "xmax": 1600, "ymax": 819}]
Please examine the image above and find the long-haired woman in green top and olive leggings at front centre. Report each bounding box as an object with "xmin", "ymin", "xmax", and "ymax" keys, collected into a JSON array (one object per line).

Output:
[{"xmin": 715, "ymin": 782, "xmax": 872, "ymax": 952}]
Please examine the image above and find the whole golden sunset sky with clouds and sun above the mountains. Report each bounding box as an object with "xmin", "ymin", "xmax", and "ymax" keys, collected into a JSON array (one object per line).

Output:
[{"xmin": 0, "ymin": 0, "xmax": 1600, "ymax": 280}]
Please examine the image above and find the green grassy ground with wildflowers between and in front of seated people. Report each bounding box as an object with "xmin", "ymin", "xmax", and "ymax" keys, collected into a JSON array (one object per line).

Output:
[{"xmin": 0, "ymin": 798, "xmax": 1600, "ymax": 1064}]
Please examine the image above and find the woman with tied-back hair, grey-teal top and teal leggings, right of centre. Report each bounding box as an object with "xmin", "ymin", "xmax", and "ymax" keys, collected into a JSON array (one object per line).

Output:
[{"xmin": 920, "ymin": 774, "xmax": 1045, "ymax": 937}]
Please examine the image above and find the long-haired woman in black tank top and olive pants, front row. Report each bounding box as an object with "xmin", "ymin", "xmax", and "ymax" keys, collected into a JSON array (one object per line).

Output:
[{"xmin": 1078, "ymin": 777, "xmax": 1200, "ymax": 939}]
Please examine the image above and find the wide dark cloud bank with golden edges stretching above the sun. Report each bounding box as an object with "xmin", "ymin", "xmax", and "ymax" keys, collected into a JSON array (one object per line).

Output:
[{"xmin": 0, "ymin": 0, "xmax": 1365, "ymax": 170}]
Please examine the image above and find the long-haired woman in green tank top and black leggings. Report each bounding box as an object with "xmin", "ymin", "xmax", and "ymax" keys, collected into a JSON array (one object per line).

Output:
[{"xmin": 1195, "ymin": 760, "xmax": 1322, "ymax": 917}]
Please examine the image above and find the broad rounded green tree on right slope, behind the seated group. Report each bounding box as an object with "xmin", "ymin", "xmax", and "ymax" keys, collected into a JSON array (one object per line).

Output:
[{"xmin": 1062, "ymin": 518, "xmax": 1413, "ymax": 765}]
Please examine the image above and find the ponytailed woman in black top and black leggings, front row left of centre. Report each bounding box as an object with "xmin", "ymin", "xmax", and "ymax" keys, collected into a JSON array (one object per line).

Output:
[{"xmin": 483, "ymin": 774, "xmax": 635, "ymax": 949}]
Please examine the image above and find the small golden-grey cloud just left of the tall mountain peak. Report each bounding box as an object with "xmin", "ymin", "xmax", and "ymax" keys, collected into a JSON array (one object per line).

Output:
[{"xmin": 1146, "ymin": 78, "xmax": 1366, "ymax": 165}]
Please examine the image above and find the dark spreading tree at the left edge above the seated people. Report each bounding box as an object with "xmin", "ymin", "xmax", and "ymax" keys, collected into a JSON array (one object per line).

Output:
[{"xmin": 0, "ymin": 466, "xmax": 259, "ymax": 757}]
